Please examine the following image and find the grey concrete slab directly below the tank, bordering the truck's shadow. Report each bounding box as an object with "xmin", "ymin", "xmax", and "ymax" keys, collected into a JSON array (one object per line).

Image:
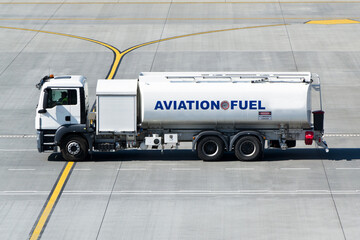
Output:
[{"xmin": 114, "ymin": 155, "xmax": 328, "ymax": 191}]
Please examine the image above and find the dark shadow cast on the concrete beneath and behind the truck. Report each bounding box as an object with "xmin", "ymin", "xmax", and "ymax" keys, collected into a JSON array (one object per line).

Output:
[{"xmin": 48, "ymin": 148, "xmax": 360, "ymax": 162}]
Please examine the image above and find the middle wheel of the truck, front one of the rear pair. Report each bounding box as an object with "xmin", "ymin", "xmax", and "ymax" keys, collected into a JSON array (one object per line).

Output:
[{"xmin": 196, "ymin": 136, "xmax": 224, "ymax": 161}]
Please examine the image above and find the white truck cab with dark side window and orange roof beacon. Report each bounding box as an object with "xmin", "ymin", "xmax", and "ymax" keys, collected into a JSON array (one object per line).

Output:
[{"xmin": 35, "ymin": 75, "xmax": 89, "ymax": 152}]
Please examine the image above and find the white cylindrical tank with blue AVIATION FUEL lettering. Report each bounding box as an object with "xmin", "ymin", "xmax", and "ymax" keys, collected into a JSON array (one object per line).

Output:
[{"xmin": 139, "ymin": 72, "xmax": 311, "ymax": 129}]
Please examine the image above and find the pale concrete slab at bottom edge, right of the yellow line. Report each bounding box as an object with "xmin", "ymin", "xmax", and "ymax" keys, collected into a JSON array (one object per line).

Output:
[{"xmin": 99, "ymin": 194, "xmax": 343, "ymax": 239}]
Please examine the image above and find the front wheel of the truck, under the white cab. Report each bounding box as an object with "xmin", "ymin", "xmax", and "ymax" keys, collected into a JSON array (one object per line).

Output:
[{"xmin": 60, "ymin": 135, "xmax": 89, "ymax": 161}]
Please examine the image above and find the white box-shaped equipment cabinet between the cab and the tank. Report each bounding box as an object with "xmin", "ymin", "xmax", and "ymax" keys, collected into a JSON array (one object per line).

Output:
[{"xmin": 96, "ymin": 79, "xmax": 137, "ymax": 133}]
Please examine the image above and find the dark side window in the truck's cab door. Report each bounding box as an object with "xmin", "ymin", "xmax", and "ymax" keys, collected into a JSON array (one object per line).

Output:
[{"xmin": 46, "ymin": 89, "xmax": 77, "ymax": 108}]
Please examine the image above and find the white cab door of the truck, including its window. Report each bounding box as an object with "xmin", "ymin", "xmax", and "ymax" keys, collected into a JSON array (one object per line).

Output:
[{"xmin": 40, "ymin": 88, "xmax": 80, "ymax": 130}]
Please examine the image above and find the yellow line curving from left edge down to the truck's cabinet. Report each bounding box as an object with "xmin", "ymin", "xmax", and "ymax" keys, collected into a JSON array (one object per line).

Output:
[{"xmin": 0, "ymin": 26, "xmax": 120, "ymax": 79}]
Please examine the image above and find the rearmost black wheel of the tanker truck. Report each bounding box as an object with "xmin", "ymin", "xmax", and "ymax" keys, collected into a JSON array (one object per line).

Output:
[{"xmin": 235, "ymin": 136, "xmax": 263, "ymax": 161}]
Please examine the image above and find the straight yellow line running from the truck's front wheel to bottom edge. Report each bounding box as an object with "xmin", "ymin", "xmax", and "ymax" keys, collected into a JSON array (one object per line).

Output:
[{"xmin": 30, "ymin": 162, "xmax": 74, "ymax": 240}]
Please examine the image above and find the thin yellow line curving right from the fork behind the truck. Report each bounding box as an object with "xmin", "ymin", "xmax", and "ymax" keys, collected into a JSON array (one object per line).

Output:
[{"xmin": 120, "ymin": 24, "xmax": 287, "ymax": 61}]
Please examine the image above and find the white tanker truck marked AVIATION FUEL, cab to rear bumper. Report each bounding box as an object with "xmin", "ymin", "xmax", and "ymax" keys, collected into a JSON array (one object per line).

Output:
[{"xmin": 35, "ymin": 72, "xmax": 328, "ymax": 161}]
